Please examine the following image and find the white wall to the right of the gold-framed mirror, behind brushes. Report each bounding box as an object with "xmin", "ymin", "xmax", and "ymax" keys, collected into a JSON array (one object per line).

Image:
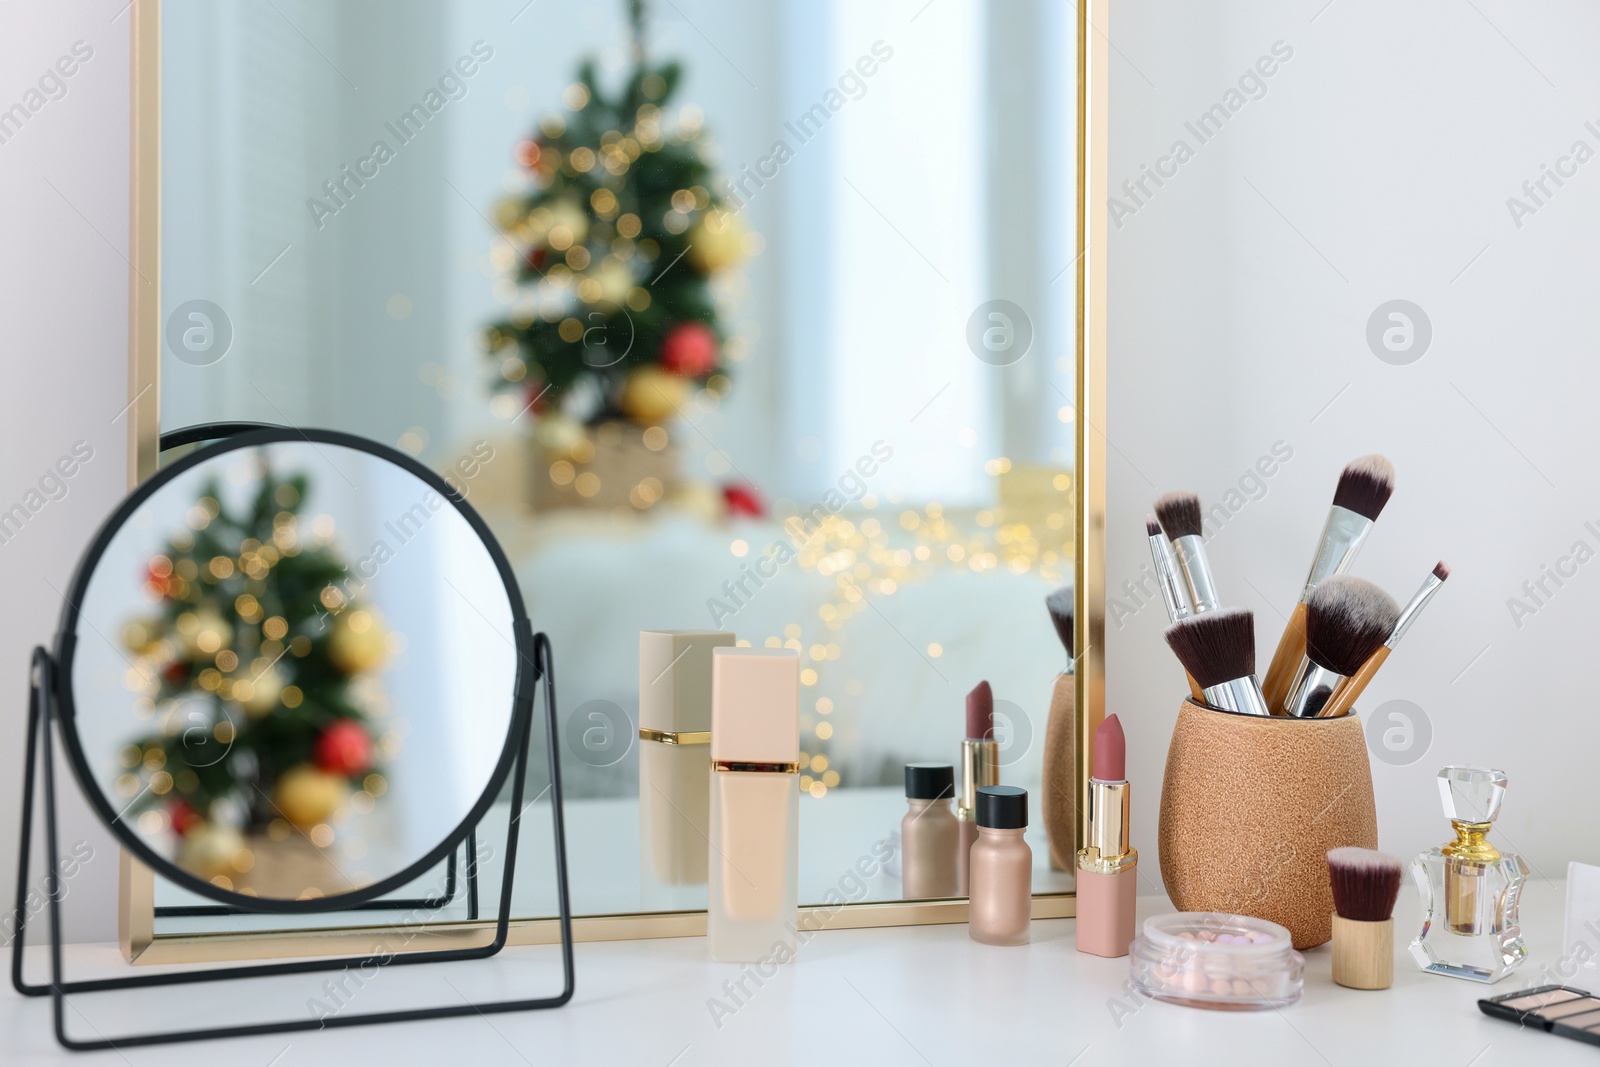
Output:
[{"xmin": 1094, "ymin": 0, "xmax": 1600, "ymax": 891}]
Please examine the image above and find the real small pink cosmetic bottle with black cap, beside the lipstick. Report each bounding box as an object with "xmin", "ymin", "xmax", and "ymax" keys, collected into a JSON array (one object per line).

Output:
[{"xmin": 966, "ymin": 785, "xmax": 1034, "ymax": 945}]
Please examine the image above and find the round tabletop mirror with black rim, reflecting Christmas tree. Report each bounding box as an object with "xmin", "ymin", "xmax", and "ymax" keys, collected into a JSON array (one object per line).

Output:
[{"xmin": 58, "ymin": 429, "xmax": 531, "ymax": 912}]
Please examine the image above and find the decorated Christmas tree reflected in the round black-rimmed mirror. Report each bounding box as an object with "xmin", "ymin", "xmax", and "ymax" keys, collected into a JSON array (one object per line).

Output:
[{"xmin": 118, "ymin": 461, "xmax": 387, "ymax": 878}]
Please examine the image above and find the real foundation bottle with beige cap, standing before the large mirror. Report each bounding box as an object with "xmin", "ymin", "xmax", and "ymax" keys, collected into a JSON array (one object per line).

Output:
[{"xmin": 706, "ymin": 648, "xmax": 800, "ymax": 963}]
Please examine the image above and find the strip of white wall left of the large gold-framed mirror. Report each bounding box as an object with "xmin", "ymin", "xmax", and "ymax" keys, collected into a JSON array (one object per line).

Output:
[{"xmin": 0, "ymin": 0, "xmax": 128, "ymax": 944}]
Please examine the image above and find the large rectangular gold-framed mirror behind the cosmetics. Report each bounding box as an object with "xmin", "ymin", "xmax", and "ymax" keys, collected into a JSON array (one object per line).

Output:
[{"xmin": 125, "ymin": 0, "xmax": 1104, "ymax": 937}]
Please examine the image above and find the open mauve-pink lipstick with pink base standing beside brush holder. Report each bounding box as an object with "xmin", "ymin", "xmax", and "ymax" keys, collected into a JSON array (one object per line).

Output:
[{"xmin": 1074, "ymin": 715, "xmax": 1139, "ymax": 958}]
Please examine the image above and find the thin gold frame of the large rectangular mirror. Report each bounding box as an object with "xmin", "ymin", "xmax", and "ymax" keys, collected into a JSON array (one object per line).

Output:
[{"xmin": 117, "ymin": 0, "xmax": 1110, "ymax": 965}]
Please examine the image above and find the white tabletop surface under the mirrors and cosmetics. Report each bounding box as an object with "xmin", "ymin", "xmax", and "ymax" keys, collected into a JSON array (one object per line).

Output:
[{"xmin": 0, "ymin": 883, "xmax": 1600, "ymax": 1067}]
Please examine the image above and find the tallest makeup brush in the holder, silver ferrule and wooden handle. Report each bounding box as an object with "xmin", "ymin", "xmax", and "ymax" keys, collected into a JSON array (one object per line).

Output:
[{"xmin": 1261, "ymin": 453, "xmax": 1395, "ymax": 707}]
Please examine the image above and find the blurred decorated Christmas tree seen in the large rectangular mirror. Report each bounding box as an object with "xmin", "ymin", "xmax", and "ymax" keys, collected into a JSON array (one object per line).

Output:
[{"xmin": 485, "ymin": 0, "xmax": 746, "ymax": 445}]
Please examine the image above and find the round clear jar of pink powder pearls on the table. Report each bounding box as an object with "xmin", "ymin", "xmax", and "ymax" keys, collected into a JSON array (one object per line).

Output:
[{"xmin": 1128, "ymin": 912, "xmax": 1306, "ymax": 1011}]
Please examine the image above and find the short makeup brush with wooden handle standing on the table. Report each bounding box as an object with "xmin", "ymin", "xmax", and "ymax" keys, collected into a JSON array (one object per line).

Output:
[{"xmin": 1328, "ymin": 848, "xmax": 1400, "ymax": 989}]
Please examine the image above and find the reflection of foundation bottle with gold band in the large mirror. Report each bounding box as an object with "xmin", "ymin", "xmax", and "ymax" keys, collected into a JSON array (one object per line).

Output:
[{"xmin": 638, "ymin": 630, "xmax": 733, "ymax": 886}]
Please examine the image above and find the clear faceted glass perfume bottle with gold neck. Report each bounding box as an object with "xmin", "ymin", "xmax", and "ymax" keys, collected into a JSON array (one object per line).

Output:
[{"xmin": 1411, "ymin": 766, "xmax": 1528, "ymax": 982}]
